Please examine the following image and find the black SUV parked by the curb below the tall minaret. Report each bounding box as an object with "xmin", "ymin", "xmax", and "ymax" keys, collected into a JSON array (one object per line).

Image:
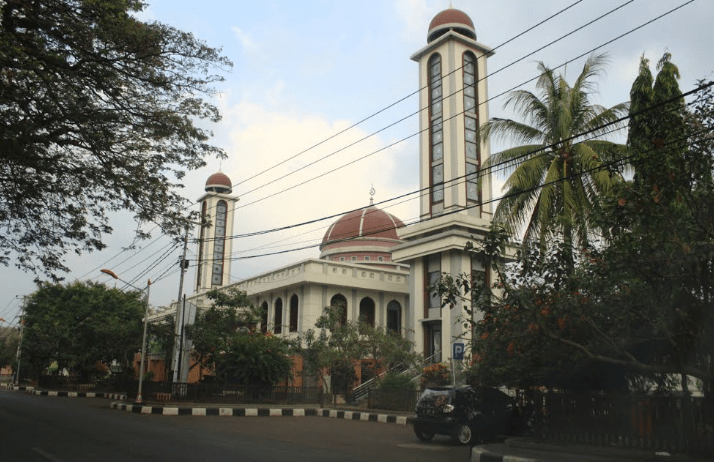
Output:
[{"xmin": 413, "ymin": 386, "xmax": 514, "ymax": 445}]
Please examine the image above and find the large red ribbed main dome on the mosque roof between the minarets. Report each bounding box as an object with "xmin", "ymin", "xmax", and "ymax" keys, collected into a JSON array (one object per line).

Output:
[{"xmin": 320, "ymin": 205, "xmax": 404, "ymax": 264}]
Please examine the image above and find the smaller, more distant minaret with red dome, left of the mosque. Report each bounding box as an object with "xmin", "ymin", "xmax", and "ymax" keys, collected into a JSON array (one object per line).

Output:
[{"xmin": 196, "ymin": 172, "xmax": 238, "ymax": 293}]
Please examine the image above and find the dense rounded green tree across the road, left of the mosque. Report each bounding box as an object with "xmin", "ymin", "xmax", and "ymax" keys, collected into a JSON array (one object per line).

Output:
[{"xmin": 22, "ymin": 282, "xmax": 146, "ymax": 379}]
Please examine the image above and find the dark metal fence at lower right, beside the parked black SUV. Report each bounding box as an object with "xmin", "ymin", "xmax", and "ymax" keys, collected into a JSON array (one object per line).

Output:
[{"xmin": 525, "ymin": 392, "xmax": 714, "ymax": 455}]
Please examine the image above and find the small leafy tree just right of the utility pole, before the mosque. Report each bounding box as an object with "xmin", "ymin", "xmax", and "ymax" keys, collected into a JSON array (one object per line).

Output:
[{"xmin": 186, "ymin": 288, "xmax": 260, "ymax": 377}]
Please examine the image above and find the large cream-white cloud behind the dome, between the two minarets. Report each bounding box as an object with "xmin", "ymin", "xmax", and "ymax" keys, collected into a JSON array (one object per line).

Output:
[{"xmin": 195, "ymin": 100, "xmax": 418, "ymax": 278}]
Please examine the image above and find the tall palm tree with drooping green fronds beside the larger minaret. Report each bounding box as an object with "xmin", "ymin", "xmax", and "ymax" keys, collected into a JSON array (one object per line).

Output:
[{"xmin": 480, "ymin": 55, "xmax": 629, "ymax": 256}]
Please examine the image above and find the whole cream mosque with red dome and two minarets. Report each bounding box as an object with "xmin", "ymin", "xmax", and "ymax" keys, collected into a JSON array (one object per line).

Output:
[{"xmin": 152, "ymin": 8, "xmax": 494, "ymax": 381}]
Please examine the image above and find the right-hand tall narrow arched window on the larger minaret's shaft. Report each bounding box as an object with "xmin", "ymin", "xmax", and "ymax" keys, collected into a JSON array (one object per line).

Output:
[{"xmin": 463, "ymin": 52, "xmax": 480, "ymax": 202}]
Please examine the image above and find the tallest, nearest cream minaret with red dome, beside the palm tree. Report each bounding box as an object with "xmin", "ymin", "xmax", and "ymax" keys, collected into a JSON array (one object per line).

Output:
[{"xmin": 392, "ymin": 8, "xmax": 493, "ymax": 361}]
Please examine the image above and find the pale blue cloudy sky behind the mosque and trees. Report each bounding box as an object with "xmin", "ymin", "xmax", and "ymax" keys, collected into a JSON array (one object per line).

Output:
[{"xmin": 0, "ymin": 0, "xmax": 714, "ymax": 325}]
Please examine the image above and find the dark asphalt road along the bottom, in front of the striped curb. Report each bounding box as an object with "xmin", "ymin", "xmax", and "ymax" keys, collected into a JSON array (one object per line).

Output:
[{"xmin": 0, "ymin": 390, "xmax": 469, "ymax": 462}]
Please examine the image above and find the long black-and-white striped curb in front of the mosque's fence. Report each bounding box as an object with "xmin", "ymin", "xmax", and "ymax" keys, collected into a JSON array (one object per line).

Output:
[{"xmin": 110, "ymin": 403, "xmax": 412, "ymax": 425}]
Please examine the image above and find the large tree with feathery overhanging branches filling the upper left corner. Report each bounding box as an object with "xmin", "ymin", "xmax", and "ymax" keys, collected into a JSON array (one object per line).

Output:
[{"xmin": 0, "ymin": 0, "xmax": 232, "ymax": 281}]
